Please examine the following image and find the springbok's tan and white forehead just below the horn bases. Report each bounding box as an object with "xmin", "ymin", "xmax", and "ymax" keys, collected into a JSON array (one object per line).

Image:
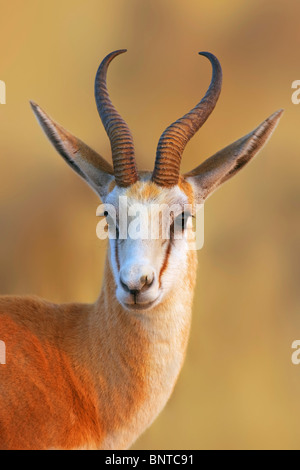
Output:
[{"xmin": 105, "ymin": 174, "xmax": 194, "ymax": 206}]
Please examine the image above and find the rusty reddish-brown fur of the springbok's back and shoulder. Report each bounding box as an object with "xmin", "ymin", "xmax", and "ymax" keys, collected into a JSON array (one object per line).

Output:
[{"xmin": 0, "ymin": 297, "xmax": 101, "ymax": 449}]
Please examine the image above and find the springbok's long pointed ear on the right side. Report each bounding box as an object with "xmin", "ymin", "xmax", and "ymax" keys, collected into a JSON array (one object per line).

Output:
[{"xmin": 184, "ymin": 110, "xmax": 283, "ymax": 202}]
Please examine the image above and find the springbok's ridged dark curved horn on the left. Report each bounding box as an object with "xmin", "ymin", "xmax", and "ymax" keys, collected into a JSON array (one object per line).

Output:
[{"xmin": 95, "ymin": 49, "xmax": 138, "ymax": 187}]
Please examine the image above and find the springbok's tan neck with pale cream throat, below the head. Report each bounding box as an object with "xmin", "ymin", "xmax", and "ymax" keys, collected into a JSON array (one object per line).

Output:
[{"xmin": 90, "ymin": 251, "xmax": 197, "ymax": 449}]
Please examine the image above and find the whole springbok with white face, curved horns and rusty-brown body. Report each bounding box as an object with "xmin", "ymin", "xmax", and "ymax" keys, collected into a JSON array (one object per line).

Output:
[{"xmin": 0, "ymin": 50, "xmax": 282, "ymax": 449}]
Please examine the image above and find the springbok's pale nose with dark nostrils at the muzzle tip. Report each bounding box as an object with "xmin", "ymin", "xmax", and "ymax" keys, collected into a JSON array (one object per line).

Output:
[{"xmin": 120, "ymin": 265, "xmax": 155, "ymax": 297}]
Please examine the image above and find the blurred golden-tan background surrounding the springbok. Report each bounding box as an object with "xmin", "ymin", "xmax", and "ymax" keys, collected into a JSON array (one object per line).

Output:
[{"xmin": 0, "ymin": 0, "xmax": 300, "ymax": 449}]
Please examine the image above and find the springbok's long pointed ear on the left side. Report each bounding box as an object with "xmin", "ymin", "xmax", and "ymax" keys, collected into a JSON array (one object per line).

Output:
[{"xmin": 30, "ymin": 101, "xmax": 114, "ymax": 198}]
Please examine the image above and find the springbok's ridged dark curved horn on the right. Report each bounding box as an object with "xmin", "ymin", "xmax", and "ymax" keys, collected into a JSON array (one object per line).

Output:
[{"xmin": 152, "ymin": 52, "xmax": 222, "ymax": 186}]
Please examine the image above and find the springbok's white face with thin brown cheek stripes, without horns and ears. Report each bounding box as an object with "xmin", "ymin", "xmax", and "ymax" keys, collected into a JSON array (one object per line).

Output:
[{"xmin": 105, "ymin": 181, "xmax": 196, "ymax": 310}]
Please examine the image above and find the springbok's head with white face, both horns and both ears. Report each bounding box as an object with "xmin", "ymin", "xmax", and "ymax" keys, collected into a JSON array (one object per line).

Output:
[{"xmin": 31, "ymin": 50, "xmax": 283, "ymax": 310}]
